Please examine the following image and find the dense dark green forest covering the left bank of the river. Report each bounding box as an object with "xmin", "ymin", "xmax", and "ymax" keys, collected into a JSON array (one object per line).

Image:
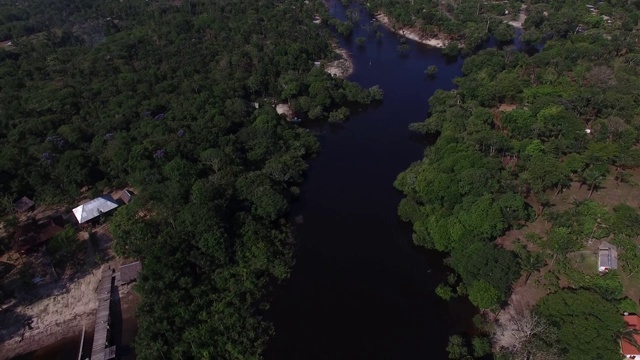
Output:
[{"xmin": 0, "ymin": 0, "xmax": 382, "ymax": 360}]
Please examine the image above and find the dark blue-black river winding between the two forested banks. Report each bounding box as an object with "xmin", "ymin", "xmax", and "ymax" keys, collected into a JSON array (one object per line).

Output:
[{"xmin": 267, "ymin": 1, "xmax": 475, "ymax": 360}]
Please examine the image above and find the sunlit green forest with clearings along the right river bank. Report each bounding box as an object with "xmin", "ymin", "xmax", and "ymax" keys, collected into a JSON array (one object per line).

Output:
[{"xmin": 392, "ymin": 1, "xmax": 640, "ymax": 360}]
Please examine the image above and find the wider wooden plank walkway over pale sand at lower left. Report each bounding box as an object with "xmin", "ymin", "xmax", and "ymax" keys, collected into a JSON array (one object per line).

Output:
[{"xmin": 91, "ymin": 268, "xmax": 115, "ymax": 360}]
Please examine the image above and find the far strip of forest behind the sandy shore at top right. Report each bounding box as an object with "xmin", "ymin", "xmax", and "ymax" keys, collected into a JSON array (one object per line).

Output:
[{"xmin": 367, "ymin": 0, "xmax": 640, "ymax": 52}]
